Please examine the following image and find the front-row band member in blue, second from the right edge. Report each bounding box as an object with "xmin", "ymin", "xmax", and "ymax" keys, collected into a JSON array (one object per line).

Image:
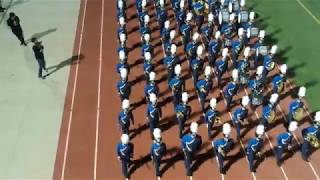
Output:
[{"xmin": 275, "ymin": 121, "xmax": 298, "ymax": 166}]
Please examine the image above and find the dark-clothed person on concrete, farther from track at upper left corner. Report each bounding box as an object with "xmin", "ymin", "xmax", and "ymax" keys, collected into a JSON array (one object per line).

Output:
[{"xmin": 7, "ymin": 12, "xmax": 27, "ymax": 46}]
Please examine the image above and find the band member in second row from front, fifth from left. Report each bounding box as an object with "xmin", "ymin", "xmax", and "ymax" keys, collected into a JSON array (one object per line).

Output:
[{"xmin": 232, "ymin": 96, "xmax": 250, "ymax": 139}]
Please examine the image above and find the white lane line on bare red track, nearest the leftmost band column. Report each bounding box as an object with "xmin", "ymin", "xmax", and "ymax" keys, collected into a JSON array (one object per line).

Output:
[{"xmin": 93, "ymin": 0, "xmax": 104, "ymax": 180}]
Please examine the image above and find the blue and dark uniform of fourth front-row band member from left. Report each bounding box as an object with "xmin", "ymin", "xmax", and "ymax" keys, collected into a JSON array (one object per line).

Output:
[{"xmin": 212, "ymin": 137, "xmax": 234, "ymax": 174}]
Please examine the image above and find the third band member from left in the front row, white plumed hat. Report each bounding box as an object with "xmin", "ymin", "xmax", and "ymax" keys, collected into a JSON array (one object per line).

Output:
[{"xmin": 181, "ymin": 122, "xmax": 202, "ymax": 177}]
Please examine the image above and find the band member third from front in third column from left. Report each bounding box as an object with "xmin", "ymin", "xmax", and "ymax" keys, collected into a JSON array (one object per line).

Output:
[{"xmin": 168, "ymin": 64, "xmax": 185, "ymax": 107}]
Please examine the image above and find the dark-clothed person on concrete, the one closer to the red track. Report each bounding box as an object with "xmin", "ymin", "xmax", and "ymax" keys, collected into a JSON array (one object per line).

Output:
[{"xmin": 31, "ymin": 38, "xmax": 48, "ymax": 79}]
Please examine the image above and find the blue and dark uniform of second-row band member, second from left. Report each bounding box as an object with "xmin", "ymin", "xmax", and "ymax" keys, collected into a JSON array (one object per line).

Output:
[{"xmin": 147, "ymin": 103, "xmax": 162, "ymax": 135}]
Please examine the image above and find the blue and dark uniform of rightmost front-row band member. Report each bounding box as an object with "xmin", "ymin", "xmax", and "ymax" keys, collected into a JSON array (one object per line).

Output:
[{"xmin": 301, "ymin": 124, "xmax": 320, "ymax": 161}]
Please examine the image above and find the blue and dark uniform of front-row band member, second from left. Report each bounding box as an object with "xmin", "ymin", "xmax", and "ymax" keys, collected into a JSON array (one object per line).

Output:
[{"xmin": 150, "ymin": 140, "xmax": 167, "ymax": 177}]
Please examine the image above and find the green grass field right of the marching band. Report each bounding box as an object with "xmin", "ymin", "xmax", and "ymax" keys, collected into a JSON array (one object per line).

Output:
[{"xmin": 247, "ymin": 0, "xmax": 320, "ymax": 111}]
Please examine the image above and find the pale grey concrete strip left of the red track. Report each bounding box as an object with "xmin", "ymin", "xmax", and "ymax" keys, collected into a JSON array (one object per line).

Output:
[{"xmin": 0, "ymin": 0, "xmax": 80, "ymax": 179}]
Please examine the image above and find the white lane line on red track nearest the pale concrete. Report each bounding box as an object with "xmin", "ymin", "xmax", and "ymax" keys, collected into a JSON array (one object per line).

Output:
[{"xmin": 61, "ymin": 0, "xmax": 88, "ymax": 180}]
